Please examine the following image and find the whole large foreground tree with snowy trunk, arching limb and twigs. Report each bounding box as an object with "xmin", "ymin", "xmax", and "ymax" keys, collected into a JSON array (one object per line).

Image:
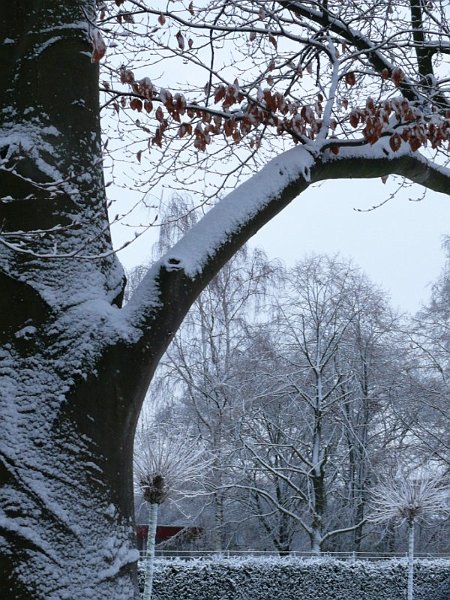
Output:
[{"xmin": 0, "ymin": 0, "xmax": 449, "ymax": 600}]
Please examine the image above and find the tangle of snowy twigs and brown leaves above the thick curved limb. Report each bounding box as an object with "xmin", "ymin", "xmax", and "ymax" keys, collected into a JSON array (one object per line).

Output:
[{"xmin": 99, "ymin": 0, "xmax": 450, "ymax": 199}]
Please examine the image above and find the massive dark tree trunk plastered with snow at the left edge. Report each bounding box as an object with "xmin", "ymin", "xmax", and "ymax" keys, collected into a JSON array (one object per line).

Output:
[{"xmin": 0, "ymin": 0, "xmax": 142, "ymax": 600}]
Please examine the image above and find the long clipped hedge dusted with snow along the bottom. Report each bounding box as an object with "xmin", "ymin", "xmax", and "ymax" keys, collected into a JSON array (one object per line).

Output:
[{"xmin": 141, "ymin": 558, "xmax": 450, "ymax": 600}]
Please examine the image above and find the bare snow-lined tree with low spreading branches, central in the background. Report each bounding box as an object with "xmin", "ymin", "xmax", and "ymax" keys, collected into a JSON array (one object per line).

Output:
[{"xmin": 229, "ymin": 256, "xmax": 386, "ymax": 552}]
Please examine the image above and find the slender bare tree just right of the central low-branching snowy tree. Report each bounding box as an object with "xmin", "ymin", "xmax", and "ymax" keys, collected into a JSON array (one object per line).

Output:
[{"xmin": 335, "ymin": 273, "xmax": 407, "ymax": 552}]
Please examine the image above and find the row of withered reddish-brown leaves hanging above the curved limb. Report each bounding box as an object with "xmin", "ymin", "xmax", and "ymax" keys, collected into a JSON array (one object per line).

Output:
[{"xmin": 120, "ymin": 69, "xmax": 450, "ymax": 154}]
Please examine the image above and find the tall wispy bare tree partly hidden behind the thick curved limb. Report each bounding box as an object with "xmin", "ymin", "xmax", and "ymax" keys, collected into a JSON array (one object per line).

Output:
[{"xmin": 132, "ymin": 196, "xmax": 279, "ymax": 552}]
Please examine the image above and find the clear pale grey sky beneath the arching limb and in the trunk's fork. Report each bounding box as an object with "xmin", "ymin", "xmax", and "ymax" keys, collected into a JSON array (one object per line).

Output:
[{"xmin": 116, "ymin": 173, "xmax": 450, "ymax": 312}]
